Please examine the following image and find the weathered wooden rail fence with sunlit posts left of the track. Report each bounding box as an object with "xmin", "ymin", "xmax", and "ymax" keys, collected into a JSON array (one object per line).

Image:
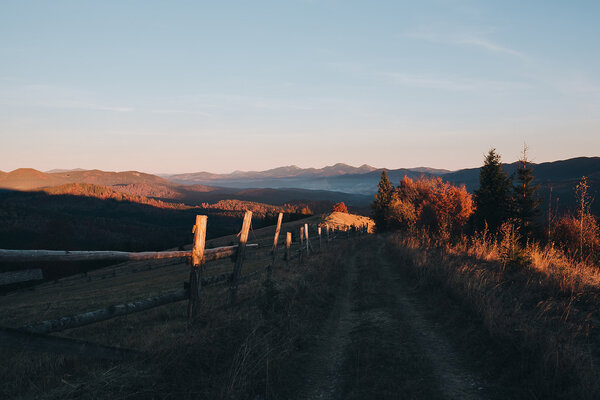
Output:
[{"xmin": 0, "ymin": 211, "xmax": 367, "ymax": 359}]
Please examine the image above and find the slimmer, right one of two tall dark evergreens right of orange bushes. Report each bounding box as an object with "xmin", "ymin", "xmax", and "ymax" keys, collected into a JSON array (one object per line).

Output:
[{"xmin": 513, "ymin": 145, "xmax": 541, "ymax": 239}]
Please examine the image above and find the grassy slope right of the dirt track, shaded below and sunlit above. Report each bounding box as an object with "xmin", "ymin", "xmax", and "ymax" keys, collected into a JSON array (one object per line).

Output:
[{"xmin": 388, "ymin": 236, "xmax": 600, "ymax": 399}]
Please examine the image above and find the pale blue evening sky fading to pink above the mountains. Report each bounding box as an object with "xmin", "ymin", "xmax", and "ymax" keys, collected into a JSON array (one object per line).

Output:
[{"xmin": 0, "ymin": 0, "xmax": 600, "ymax": 173}]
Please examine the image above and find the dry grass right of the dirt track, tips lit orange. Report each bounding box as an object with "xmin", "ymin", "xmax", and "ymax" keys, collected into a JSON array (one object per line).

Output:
[{"xmin": 388, "ymin": 233, "xmax": 600, "ymax": 399}]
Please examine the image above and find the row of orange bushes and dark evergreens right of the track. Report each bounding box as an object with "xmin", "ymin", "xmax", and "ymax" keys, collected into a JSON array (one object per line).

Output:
[{"xmin": 371, "ymin": 146, "xmax": 600, "ymax": 261}]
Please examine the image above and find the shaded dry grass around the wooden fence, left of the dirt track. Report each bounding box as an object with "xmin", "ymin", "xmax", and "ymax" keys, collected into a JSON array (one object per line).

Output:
[{"xmin": 0, "ymin": 225, "xmax": 350, "ymax": 399}]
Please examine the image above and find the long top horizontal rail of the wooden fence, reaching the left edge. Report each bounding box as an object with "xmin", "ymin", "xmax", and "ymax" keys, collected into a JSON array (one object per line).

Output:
[{"xmin": 0, "ymin": 244, "xmax": 258, "ymax": 262}]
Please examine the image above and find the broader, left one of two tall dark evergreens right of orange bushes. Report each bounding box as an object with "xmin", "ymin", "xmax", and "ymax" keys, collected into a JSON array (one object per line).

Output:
[{"xmin": 474, "ymin": 149, "xmax": 512, "ymax": 231}]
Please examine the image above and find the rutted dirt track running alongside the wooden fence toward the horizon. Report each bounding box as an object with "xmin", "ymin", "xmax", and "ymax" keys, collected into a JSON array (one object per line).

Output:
[{"xmin": 298, "ymin": 238, "xmax": 486, "ymax": 399}]
